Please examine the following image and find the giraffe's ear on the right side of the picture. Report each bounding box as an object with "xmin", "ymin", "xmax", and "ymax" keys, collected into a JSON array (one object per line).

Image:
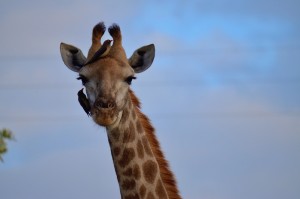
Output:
[{"xmin": 128, "ymin": 44, "xmax": 155, "ymax": 73}]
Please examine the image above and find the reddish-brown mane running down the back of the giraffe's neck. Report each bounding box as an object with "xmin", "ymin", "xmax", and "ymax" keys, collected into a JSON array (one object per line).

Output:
[{"xmin": 129, "ymin": 90, "xmax": 181, "ymax": 199}]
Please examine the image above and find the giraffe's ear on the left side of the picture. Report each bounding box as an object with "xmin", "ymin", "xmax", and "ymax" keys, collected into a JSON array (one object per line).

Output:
[{"xmin": 60, "ymin": 43, "xmax": 86, "ymax": 72}]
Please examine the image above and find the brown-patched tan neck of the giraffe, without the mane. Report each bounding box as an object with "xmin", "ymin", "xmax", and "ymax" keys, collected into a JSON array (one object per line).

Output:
[{"xmin": 107, "ymin": 91, "xmax": 169, "ymax": 199}]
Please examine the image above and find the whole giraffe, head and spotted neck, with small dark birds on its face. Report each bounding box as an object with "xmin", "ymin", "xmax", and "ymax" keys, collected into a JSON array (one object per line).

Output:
[{"xmin": 60, "ymin": 22, "xmax": 181, "ymax": 199}]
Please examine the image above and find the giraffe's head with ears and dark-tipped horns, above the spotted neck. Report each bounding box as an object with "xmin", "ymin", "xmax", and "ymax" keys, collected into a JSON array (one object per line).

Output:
[{"xmin": 60, "ymin": 22, "xmax": 155, "ymax": 127}]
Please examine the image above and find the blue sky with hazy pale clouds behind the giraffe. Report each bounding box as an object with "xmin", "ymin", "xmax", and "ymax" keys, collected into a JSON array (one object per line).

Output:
[{"xmin": 0, "ymin": 0, "xmax": 300, "ymax": 199}]
